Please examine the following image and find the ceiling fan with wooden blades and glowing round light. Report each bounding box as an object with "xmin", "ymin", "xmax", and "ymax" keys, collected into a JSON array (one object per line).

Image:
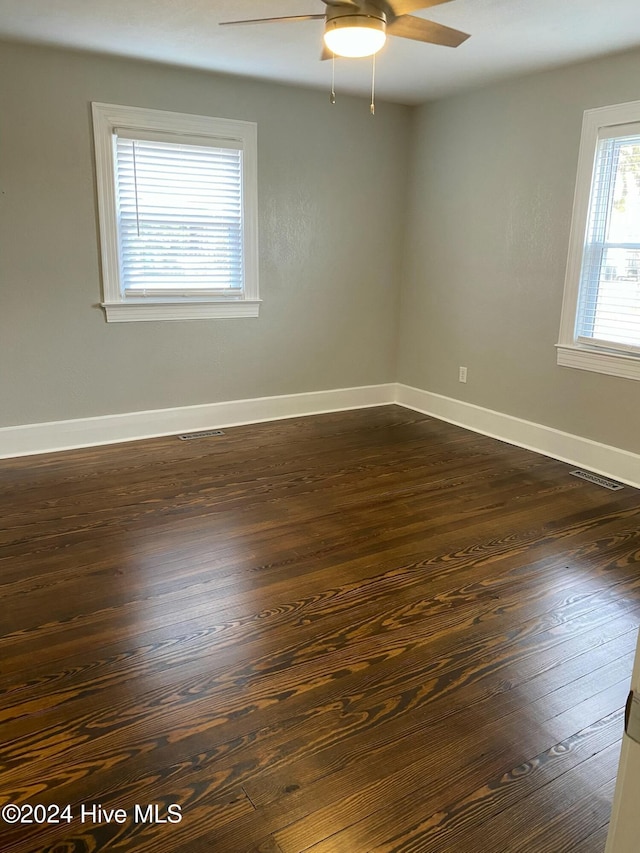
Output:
[{"xmin": 221, "ymin": 0, "xmax": 469, "ymax": 59}]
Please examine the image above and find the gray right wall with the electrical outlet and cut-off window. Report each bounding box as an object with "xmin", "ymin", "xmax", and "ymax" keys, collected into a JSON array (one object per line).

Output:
[{"xmin": 398, "ymin": 52, "xmax": 640, "ymax": 452}]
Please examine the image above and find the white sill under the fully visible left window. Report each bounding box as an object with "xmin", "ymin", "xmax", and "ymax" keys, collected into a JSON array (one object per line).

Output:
[{"xmin": 101, "ymin": 299, "xmax": 261, "ymax": 323}]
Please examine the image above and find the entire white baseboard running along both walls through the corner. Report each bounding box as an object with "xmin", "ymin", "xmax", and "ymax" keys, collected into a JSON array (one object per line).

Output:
[{"xmin": 0, "ymin": 382, "xmax": 640, "ymax": 488}]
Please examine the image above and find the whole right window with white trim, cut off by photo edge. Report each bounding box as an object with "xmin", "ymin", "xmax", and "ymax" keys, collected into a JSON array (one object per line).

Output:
[{"xmin": 558, "ymin": 101, "xmax": 640, "ymax": 379}]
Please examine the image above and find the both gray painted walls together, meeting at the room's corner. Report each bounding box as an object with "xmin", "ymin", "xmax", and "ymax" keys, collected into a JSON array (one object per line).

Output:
[{"xmin": 0, "ymin": 38, "xmax": 640, "ymax": 460}]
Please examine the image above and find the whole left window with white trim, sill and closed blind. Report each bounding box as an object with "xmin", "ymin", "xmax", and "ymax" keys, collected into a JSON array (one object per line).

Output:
[{"xmin": 93, "ymin": 104, "xmax": 260, "ymax": 322}]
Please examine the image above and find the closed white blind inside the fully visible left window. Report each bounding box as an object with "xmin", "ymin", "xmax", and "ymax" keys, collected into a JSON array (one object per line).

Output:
[{"xmin": 115, "ymin": 131, "xmax": 244, "ymax": 298}]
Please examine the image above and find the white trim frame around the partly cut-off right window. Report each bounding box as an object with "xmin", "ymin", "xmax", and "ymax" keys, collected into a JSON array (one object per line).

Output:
[{"xmin": 556, "ymin": 101, "xmax": 640, "ymax": 379}]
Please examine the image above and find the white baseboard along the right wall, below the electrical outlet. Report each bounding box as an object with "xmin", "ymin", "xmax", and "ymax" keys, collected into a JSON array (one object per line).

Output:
[{"xmin": 396, "ymin": 383, "xmax": 640, "ymax": 488}]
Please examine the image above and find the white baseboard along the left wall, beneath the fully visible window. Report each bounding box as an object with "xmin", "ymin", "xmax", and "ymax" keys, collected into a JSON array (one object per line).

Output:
[{"xmin": 0, "ymin": 383, "xmax": 396, "ymax": 459}]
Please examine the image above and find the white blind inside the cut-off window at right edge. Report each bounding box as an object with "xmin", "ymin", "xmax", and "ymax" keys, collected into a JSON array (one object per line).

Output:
[{"xmin": 576, "ymin": 134, "xmax": 640, "ymax": 352}]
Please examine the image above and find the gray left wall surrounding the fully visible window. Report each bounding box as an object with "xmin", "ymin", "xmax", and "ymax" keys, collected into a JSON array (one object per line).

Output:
[{"xmin": 0, "ymin": 44, "xmax": 410, "ymax": 426}]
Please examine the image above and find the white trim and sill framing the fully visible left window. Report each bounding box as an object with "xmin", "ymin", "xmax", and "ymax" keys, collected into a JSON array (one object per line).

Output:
[{"xmin": 91, "ymin": 103, "xmax": 261, "ymax": 323}]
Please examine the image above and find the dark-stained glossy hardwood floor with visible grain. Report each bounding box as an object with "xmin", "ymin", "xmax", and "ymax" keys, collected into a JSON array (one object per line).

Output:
[{"xmin": 0, "ymin": 406, "xmax": 640, "ymax": 853}]
